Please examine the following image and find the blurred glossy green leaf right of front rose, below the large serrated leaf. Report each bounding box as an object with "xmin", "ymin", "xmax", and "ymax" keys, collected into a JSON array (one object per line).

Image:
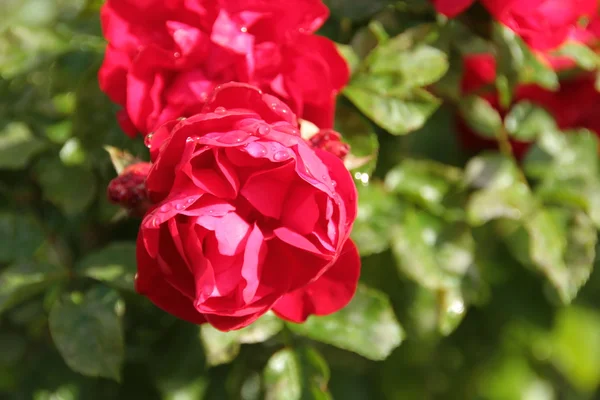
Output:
[{"xmin": 385, "ymin": 159, "xmax": 464, "ymax": 219}]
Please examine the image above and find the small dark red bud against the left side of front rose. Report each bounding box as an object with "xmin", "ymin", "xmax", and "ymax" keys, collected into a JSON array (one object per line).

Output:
[{"xmin": 106, "ymin": 162, "xmax": 151, "ymax": 217}]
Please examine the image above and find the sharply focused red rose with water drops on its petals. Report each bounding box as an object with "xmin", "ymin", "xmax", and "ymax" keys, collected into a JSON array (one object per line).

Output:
[{"xmin": 136, "ymin": 83, "xmax": 360, "ymax": 331}]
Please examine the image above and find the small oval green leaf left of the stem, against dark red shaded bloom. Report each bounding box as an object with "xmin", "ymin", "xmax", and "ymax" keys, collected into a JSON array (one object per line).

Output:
[{"xmin": 459, "ymin": 96, "xmax": 502, "ymax": 138}]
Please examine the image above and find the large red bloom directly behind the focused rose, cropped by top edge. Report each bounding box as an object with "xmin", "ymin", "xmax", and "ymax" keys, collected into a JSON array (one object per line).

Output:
[{"xmin": 99, "ymin": 0, "xmax": 349, "ymax": 136}]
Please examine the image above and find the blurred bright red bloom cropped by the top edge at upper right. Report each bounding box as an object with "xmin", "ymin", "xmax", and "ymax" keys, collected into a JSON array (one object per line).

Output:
[{"xmin": 432, "ymin": 0, "xmax": 598, "ymax": 52}]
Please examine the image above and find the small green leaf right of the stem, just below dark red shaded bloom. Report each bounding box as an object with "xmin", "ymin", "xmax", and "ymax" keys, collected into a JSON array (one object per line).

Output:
[{"xmin": 504, "ymin": 101, "xmax": 557, "ymax": 141}]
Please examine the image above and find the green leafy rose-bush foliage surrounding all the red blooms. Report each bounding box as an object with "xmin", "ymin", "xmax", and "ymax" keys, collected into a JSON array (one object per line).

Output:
[{"xmin": 0, "ymin": 0, "xmax": 600, "ymax": 400}]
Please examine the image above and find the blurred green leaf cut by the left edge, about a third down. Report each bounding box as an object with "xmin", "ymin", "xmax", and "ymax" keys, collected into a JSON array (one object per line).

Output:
[{"xmin": 0, "ymin": 122, "xmax": 46, "ymax": 169}]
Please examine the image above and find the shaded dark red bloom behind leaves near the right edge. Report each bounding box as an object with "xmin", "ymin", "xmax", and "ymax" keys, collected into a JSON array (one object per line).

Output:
[{"xmin": 459, "ymin": 54, "xmax": 600, "ymax": 158}]
